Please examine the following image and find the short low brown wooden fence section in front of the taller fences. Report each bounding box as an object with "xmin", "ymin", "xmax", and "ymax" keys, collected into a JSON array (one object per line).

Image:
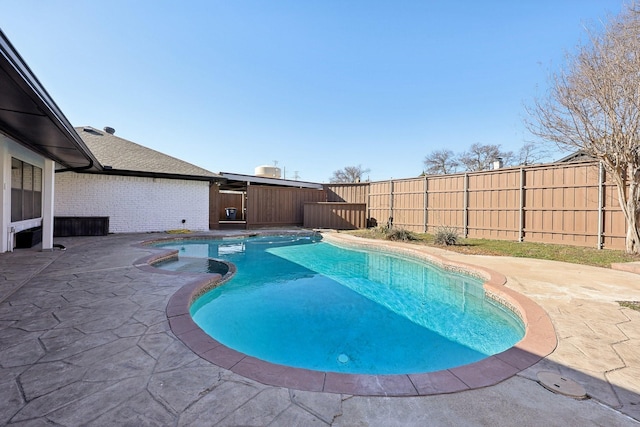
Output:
[{"xmin": 304, "ymin": 202, "xmax": 367, "ymax": 230}]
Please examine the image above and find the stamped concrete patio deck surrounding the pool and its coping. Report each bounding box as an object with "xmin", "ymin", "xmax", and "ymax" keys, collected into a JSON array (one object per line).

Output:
[{"xmin": 0, "ymin": 232, "xmax": 640, "ymax": 426}]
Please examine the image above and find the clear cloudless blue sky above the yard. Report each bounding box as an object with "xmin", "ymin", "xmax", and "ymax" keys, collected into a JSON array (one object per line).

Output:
[{"xmin": 0, "ymin": 0, "xmax": 624, "ymax": 182}]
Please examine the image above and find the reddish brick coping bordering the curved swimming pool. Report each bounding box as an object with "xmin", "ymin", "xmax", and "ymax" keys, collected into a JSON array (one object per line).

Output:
[{"xmin": 134, "ymin": 232, "xmax": 557, "ymax": 396}]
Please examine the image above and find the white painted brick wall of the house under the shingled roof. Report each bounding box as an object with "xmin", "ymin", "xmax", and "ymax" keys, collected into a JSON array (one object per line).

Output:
[{"xmin": 55, "ymin": 172, "xmax": 209, "ymax": 233}]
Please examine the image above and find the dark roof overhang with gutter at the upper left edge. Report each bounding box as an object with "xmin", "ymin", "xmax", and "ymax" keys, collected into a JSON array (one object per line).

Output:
[{"xmin": 0, "ymin": 30, "xmax": 102, "ymax": 171}]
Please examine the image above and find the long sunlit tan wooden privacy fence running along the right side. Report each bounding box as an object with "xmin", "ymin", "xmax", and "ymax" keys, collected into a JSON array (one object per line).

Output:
[{"xmin": 325, "ymin": 162, "xmax": 626, "ymax": 249}]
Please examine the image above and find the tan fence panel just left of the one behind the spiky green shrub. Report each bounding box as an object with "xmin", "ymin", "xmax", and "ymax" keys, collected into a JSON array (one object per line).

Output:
[{"xmin": 393, "ymin": 178, "xmax": 425, "ymax": 232}]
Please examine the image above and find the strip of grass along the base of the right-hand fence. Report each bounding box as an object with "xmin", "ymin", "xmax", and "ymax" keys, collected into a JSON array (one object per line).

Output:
[{"xmin": 348, "ymin": 229, "xmax": 640, "ymax": 268}]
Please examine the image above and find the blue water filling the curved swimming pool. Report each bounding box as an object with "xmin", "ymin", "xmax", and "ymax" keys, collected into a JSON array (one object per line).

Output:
[{"xmin": 155, "ymin": 236, "xmax": 524, "ymax": 374}]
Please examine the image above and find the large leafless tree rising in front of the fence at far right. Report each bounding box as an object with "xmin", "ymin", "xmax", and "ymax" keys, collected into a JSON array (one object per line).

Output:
[{"xmin": 527, "ymin": 6, "xmax": 640, "ymax": 253}]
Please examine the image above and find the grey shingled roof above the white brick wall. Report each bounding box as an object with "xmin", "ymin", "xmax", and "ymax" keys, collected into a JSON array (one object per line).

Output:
[{"xmin": 76, "ymin": 126, "xmax": 220, "ymax": 181}]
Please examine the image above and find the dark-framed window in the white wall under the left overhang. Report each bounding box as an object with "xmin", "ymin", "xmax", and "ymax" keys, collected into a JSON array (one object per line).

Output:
[{"xmin": 11, "ymin": 158, "xmax": 42, "ymax": 222}]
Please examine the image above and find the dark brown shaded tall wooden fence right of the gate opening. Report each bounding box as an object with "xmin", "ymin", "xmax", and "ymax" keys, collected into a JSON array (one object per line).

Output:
[{"xmin": 246, "ymin": 185, "xmax": 326, "ymax": 228}]
